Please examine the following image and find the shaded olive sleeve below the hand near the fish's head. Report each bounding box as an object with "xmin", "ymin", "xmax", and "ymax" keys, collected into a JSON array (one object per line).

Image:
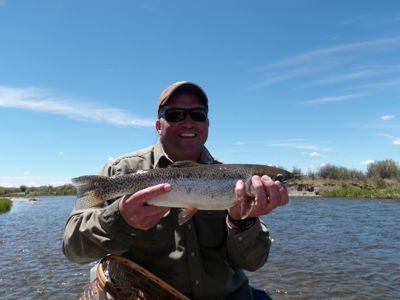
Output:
[{"xmin": 226, "ymin": 219, "xmax": 271, "ymax": 271}]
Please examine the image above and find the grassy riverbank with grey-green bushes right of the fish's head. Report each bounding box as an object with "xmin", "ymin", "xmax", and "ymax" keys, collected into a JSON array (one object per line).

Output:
[{"xmin": 293, "ymin": 160, "xmax": 400, "ymax": 199}]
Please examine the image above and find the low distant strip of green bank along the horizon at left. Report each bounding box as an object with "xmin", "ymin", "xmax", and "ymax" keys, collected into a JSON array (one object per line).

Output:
[{"xmin": 0, "ymin": 184, "xmax": 76, "ymax": 197}]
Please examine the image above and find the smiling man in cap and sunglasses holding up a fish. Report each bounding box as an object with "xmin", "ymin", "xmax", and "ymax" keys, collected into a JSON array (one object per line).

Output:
[{"xmin": 63, "ymin": 82, "xmax": 288, "ymax": 299}]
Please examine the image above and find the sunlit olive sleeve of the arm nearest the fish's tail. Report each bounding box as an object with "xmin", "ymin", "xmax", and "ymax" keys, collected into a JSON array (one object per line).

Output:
[{"xmin": 63, "ymin": 164, "xmax": 140, "ymax": 263}]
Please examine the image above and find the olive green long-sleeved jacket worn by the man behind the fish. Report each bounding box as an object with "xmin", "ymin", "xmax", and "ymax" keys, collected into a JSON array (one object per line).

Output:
[{"xmin": 63, "ymin": 142, "xmax": 271, "ymax": 300}]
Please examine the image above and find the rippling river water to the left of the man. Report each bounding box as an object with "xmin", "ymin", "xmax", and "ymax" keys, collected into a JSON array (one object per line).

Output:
[{"xmin": 0, "ymin": 197, "xmax": 89, "ymax": 299}]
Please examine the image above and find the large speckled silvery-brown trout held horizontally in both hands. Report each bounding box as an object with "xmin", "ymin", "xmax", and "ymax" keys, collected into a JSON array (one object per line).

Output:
[{"xmin": 72, "ymin": 161, "xmax": 292, "ymax": 225}]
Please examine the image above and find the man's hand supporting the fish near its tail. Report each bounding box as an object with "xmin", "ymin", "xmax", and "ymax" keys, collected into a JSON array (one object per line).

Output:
[{"xmin": 119, "ymin": 183, "xmax": 172, "ymax": 230}]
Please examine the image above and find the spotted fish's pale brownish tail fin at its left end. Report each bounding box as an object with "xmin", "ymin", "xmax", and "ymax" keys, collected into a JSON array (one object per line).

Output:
[{"xmin": 72, "ymin": 175, "xmax": 108, "ymax": 209}]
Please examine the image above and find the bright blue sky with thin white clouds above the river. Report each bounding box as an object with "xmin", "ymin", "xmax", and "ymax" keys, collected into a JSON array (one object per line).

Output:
[{"xmin": 0, "ymin": 0, "xmax": 400, "ymax": 187}]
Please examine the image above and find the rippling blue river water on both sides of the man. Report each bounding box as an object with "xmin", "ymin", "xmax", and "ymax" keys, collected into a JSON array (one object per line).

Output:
[{"xmin": 0, "ymin": 197, "xmax": 400, "ymax": 299}]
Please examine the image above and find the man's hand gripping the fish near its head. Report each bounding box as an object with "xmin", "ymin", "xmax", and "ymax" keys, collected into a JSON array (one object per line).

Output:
[{"xmin": 229, "ymin": 175, "xmax": 289, "ymax": 220}]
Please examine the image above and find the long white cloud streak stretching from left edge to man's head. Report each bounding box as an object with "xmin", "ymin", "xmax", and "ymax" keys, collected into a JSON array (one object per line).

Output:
[{"xmin": 0, "ymin": 86, "xmax": 154, "ymax": 126}]
